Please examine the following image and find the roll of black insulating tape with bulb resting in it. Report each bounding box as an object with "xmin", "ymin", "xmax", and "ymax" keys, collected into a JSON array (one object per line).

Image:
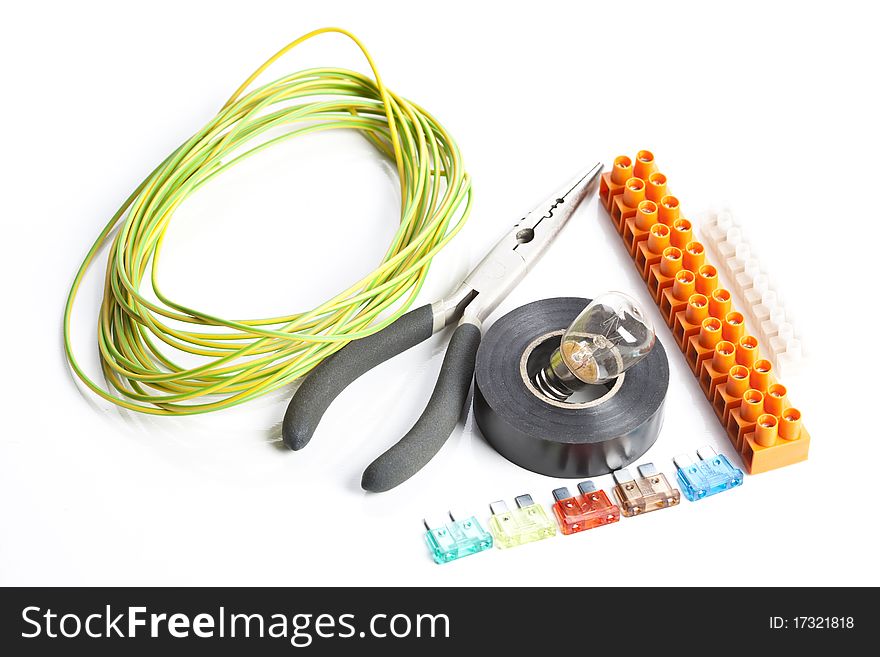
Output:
[{"xmin": 474, "ymin": 297, "xmax": 669, "ymax": 478}]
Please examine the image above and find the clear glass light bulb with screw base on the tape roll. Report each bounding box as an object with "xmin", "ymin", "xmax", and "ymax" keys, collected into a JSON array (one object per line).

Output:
[{"xmin": 535, "ymin": 292, "xmax": 655, "ymax": 401}]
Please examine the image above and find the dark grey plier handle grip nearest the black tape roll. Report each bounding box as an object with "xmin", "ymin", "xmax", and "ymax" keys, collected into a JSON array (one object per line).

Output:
[{"xmin": 361, "ymin": 324, "xmax": 482, "ymax": 493}]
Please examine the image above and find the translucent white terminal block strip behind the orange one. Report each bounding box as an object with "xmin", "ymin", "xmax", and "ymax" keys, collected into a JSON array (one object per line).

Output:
[{"xmin": 697, "ymin": 207, "xmax": 803, "ymax": 378}]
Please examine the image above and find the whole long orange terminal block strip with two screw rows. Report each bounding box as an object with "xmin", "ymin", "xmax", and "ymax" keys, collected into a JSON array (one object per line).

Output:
[{"xmin": 600, "ymin": 150, "xmax": 810, "ymax": 474}]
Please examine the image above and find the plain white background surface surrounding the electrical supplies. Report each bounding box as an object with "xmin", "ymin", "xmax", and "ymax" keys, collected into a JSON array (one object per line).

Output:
[{"xmin": 0, "ymin": 0, "xmax": 880, "ymax": 586}]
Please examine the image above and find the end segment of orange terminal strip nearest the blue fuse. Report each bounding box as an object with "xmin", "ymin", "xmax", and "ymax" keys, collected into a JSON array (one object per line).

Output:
[{"xmin": 740, "ymin": 408, "xmax": 810, "ymax": 474}]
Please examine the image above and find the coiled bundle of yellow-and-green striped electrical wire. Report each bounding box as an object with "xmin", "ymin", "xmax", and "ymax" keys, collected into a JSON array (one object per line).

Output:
[{"xmin": 64, "ymin": 28, "xmax": 471, "ymax": 415}]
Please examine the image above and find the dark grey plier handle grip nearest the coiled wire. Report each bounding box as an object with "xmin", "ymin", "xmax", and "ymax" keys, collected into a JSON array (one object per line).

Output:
[{"xmin": 281, "ymin": 304, "xmax": 434, "ymax": 449}]
